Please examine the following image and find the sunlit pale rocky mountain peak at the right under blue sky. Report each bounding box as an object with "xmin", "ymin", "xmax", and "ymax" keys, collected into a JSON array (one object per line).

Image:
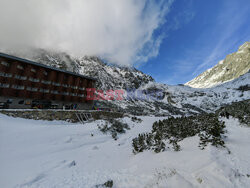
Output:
[{"xmin": 186, "ymin": 42, "xmax": 250, "ymax": 88}]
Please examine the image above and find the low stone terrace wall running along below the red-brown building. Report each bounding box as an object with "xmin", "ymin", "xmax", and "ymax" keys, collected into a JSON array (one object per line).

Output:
[{"xmin": 0, "ymin": 110, "xmax": 124, "ymax": 123}]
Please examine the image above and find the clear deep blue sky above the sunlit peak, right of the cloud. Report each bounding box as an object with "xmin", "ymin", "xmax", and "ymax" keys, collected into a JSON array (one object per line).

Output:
[{"xmin": 137, "ymin": 0, "xmax": 250, "ymax": 85}]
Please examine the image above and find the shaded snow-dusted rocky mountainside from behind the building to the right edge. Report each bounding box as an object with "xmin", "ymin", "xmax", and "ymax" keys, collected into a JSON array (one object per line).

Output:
[{"xmin": 5, "ymin": 45, "xmax": 250, "ymax": 115}]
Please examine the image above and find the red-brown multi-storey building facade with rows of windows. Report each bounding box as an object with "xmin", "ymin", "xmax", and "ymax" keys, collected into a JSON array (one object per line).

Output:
[{"xmin": 0, "ymin": 53, "xmax": 96, "ymax": 109}]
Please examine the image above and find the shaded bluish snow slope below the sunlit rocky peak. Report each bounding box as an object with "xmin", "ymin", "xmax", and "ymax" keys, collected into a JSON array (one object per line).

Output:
[{"xmin": 143, "ymin": 72, "xmax": 250, "ymax": 113}]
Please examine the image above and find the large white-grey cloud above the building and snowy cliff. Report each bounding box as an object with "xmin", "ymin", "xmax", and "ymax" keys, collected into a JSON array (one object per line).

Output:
[{"xmin": 0, "ymin": 0, "xmax": 173, "ymax": 65}]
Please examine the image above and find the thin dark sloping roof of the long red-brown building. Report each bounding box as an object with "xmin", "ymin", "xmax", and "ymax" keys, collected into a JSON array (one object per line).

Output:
[{"xmin": 0, "ymin": 52, "xmax": 96, "ymax": 81}]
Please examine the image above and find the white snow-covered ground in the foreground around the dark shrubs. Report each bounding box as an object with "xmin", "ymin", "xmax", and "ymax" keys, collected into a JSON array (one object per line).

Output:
[{"xmin": 0, "ymin": 114, "xmax": 250, "ymax": 188}]
